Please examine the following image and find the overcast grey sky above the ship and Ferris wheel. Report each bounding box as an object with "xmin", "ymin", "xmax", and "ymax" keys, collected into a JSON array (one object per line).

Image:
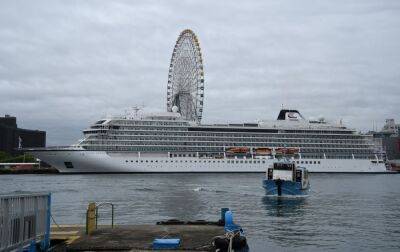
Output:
[{"xmin": 0, "ymin": 0, "xmax": 400, "ymax": 145}]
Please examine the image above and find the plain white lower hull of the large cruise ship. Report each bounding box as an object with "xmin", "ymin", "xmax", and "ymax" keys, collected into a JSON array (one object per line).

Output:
[{"xmin": 31, "ymin": 150, "xmax": 388, "ymax": 173}]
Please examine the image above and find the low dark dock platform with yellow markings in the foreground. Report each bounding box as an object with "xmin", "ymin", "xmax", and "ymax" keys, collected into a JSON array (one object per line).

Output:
[{"xmin": 51, "ymin": 224, "xmax": 225, "ymax": 251}]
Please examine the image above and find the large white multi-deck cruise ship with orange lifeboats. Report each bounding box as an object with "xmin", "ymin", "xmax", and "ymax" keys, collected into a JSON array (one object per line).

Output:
[{"xmin": 29, "ymin": 109, "xmax": 386, "ymax": 173}]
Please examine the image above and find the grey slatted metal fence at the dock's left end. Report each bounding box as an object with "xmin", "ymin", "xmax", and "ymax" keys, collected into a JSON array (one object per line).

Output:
[{"xmin": 0, "ymin": 193, "xmax": 51, "ymax": 251}]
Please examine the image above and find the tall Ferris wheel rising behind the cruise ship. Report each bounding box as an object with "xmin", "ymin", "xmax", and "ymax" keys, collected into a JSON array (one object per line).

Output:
[{"xmin": 167, "ymin": 30, "xmax": 204, "ymax": 122}]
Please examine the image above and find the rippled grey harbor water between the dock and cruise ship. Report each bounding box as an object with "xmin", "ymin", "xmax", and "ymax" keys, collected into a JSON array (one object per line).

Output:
[{"xmin": 0, "ymin": 174, "xmax": 400, "ymax": 251}]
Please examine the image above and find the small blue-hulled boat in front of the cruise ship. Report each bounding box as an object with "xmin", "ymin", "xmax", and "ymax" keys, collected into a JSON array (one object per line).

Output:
[{"xmin": 263, "ymin": 160, "xmax": 310, "ymax": 196}]
